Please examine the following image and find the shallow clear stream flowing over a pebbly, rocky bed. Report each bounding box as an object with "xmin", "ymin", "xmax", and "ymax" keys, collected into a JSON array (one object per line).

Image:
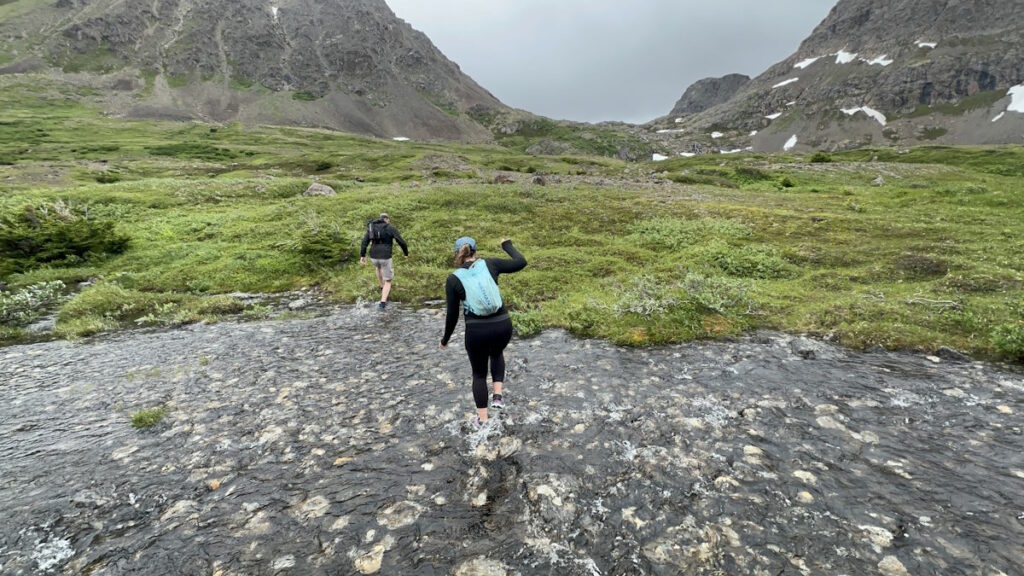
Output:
[{"xmin": 0, "ymin": 306, "xmax": 1024, "ymax": 576}]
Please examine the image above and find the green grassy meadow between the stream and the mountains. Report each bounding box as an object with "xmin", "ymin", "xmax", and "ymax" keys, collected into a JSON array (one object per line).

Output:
[{"xmin": 0, "ymin": 78, "xmax": 1024, "ymax": 362}]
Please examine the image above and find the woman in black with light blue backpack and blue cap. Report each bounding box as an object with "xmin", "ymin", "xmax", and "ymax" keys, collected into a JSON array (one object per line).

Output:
[{"xmin": 441, "ymin": 237, "xmax": 526, "ymax": 426}]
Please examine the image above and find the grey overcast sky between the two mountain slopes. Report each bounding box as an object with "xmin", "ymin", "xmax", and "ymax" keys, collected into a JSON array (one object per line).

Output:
[{"xmin": 386, "ymin": 0, "xmax": 836, "ymax": 123}]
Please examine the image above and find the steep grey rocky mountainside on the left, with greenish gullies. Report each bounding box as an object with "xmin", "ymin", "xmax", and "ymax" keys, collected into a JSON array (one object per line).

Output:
[{"xmin": 0, "ymin": 0, "xmax": 505, "ymax": 140}]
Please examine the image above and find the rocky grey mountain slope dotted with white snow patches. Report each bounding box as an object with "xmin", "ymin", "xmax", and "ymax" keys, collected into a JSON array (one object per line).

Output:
[{"xmin": 653, "ymin": 0, "xmax": 1024, "ymax": 152}]
